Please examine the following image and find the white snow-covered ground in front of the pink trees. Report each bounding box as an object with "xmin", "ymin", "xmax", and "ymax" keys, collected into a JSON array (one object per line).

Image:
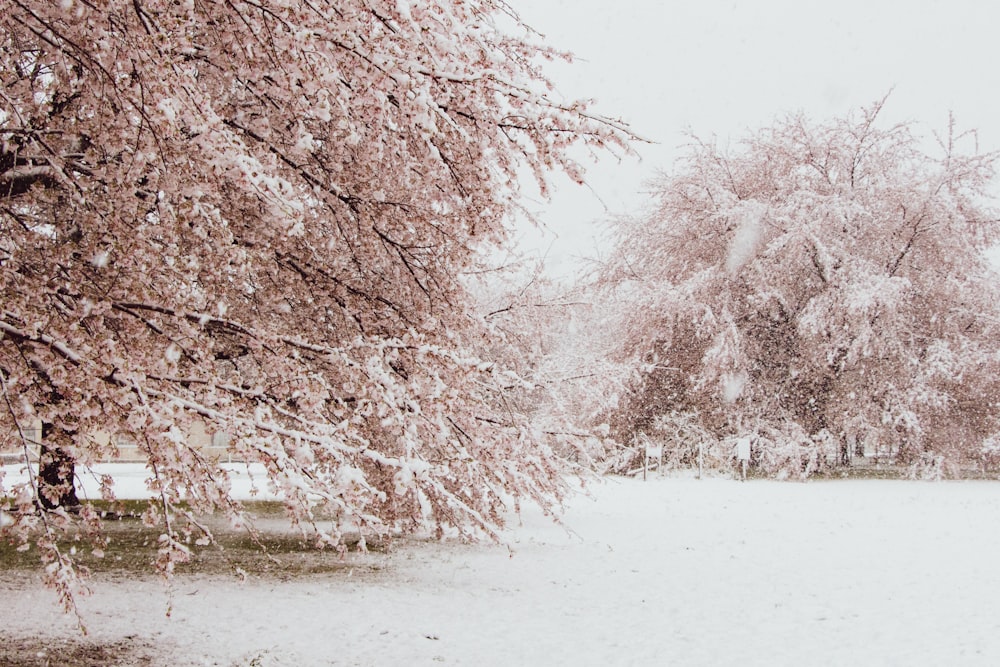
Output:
[{"xmin": 0, "ymin": 477, "xmax": 1000, "ymax": 666}]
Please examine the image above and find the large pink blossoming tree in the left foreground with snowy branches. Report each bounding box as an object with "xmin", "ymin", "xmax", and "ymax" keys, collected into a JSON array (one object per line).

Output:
[{"xmin": 0, "ymin": 0, "xmax": 630, "ymax": 604}]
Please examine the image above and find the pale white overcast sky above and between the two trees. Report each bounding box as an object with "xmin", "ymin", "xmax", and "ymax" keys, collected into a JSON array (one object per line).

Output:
[{"xmin": 511, "ymin": 0, "xmax": 1000, "ymax": 275}]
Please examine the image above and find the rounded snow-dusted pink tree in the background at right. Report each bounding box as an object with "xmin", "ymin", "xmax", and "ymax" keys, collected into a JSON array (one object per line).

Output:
[{"xmin": 602, "ymin": 100, "xmax": 1000, "ymax": 473}]
